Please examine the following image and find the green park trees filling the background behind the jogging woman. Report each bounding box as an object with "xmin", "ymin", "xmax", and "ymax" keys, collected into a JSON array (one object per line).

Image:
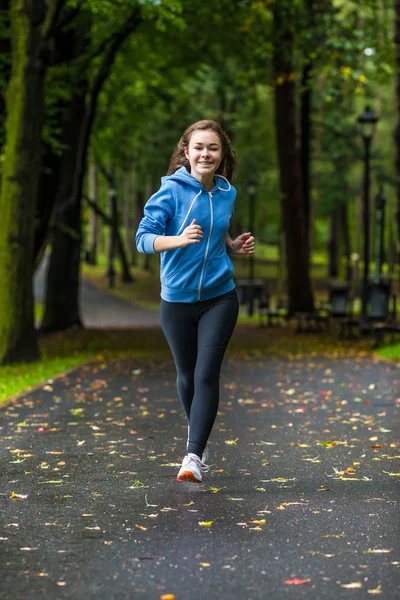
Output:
[{"xmin": 0, "ymin": 0, "xmax": 400, "ymax": 362}]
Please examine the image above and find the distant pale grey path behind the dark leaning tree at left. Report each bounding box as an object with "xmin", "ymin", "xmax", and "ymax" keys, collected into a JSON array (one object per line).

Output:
[{"xmin": 34, "ymin": 257, "xmax": 160, "ymax": 328}]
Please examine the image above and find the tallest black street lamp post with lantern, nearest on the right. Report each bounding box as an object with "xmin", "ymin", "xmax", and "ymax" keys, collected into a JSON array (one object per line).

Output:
[{"xmin": 358, "ymin": 106, "xmax": 378, "ymax": 332}]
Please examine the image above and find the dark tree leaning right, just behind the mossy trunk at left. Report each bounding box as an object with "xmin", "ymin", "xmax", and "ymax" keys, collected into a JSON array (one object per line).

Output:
[{"xmin": 40, "ymin": 0, "xmax": 183, "ymax": 331}]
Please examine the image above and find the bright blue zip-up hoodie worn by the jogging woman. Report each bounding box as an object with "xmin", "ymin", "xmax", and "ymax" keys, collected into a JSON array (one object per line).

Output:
[{"xmin": 136, "ymin": 167, "xmax": 236, "ymax": 302}]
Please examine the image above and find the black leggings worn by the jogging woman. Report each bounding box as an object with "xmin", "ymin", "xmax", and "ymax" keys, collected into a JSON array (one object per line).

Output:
[{"xmin": 160, "ymin": 290, "xmax": 239, "ymax": 457}]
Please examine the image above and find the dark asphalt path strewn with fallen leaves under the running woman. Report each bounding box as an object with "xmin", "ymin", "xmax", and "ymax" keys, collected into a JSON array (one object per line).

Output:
[{"xmin": 0, "ymin": 354, "xmax": 400, "ymax": 600}]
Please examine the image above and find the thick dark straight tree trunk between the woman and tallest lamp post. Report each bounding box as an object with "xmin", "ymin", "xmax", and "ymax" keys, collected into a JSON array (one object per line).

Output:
[{"xmin": 273, "ymin": 3, "xmax": 314, "ymax": 314}]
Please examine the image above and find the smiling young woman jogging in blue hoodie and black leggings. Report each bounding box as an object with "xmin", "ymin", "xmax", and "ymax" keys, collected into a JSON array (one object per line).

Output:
[{"xmin": 136, "ymin": 120, "xmax": 254, "ymax": 483}]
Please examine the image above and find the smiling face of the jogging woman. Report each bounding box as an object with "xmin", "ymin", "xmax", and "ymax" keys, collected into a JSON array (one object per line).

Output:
[{"xmin": 185, "ymin": 129, "xmax": 222, "ymax": 183}]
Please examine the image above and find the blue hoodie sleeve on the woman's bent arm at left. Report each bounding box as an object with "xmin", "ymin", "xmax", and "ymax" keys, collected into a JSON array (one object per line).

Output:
[{"xmin": 136, "ymin": 185, "xmax": 175, "ymax": 254}]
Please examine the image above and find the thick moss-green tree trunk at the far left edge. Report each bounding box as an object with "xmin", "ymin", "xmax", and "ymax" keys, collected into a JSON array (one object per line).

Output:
[{"xmin": 0, "ymin": 0, "xmax": 46, "ymax": 364}]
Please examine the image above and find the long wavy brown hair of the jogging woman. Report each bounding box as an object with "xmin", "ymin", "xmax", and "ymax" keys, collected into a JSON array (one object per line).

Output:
[{"xmin": 168, "ymin": 119, "xmax": 236, "ymax": 180}]
